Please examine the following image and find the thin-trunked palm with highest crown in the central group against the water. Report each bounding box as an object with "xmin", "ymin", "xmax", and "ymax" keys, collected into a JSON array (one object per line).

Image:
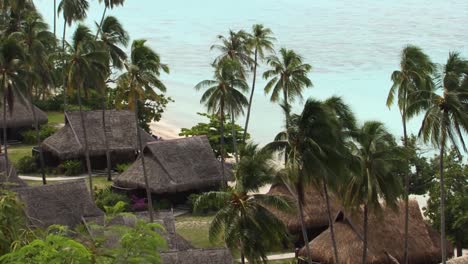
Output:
[{"xmin": 242, "ymin": 24, "xmax": 275, "ymax": 143}]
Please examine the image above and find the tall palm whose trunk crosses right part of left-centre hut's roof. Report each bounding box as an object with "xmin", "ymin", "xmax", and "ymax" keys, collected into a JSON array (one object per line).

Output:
[{"xmin": 96, "ymin": 16, "xmax": 130, "ymax": 181}]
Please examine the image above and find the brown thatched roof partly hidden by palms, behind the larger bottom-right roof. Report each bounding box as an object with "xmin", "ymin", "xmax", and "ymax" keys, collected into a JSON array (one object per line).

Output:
[{"xmin": 268, "ymin": 184, "xmax": 340, "ymax": 233}]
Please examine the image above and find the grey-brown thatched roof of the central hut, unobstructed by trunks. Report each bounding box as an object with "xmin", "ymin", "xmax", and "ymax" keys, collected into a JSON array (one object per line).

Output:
[{"xmin": 114, "ymin": 136, "xmax": 221, "ymax": 194}]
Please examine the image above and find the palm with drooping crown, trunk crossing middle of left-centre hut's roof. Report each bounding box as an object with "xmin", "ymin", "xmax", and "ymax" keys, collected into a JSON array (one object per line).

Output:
[{"xmin": 65, "ymin": 25, "xmax": 109, "ymax": 198}]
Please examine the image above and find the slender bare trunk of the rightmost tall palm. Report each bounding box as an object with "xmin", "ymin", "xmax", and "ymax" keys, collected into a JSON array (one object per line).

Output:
[{"xmin": 439, "ymin": 110, "xmax": 447, "ymax": 264}]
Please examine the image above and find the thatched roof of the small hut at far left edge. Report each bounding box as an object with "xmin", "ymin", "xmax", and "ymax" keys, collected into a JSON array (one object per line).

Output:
[{"xmin": 0, "ymin": 93, "xmax": 48, "ymax": 128}]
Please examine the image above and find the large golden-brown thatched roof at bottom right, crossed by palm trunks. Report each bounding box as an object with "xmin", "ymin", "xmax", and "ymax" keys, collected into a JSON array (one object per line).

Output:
[{"xmin": 299, "ymin": 201, "xmax": 439, "ymax": 264}]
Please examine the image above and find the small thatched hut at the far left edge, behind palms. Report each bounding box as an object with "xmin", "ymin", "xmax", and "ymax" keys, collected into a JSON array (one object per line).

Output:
[{"xmin": 0, "ymin": 92, "xmax": 48, "ymax": 141}]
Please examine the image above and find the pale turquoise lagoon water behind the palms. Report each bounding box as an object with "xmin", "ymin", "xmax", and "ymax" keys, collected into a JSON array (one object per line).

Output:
[{"xmin": 34, "ymin": 0, "xmax": 468, "ymax": 144}]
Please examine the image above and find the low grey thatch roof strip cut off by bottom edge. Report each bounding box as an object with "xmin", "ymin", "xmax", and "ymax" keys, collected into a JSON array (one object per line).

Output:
[{"xmin": 161, "ymin": 248, "xmax": 234, "ymax": 264}]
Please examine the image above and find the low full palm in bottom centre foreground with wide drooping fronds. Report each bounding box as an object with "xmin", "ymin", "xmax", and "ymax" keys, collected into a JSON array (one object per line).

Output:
[{"xmin": 194, "ymin": 144, "xmax": 291, "ymax": 263}]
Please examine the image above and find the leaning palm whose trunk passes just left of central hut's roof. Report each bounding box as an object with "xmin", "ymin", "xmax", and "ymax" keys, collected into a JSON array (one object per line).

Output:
[{"xmin": 118, "ymin": 40, "xmax": 169, "ymax": 222}]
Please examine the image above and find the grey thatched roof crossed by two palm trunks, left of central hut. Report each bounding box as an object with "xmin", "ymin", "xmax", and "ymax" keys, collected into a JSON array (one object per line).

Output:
[{"xmin": 42, "ymin": 110, "xmax": 155, "ymax": 160}]
